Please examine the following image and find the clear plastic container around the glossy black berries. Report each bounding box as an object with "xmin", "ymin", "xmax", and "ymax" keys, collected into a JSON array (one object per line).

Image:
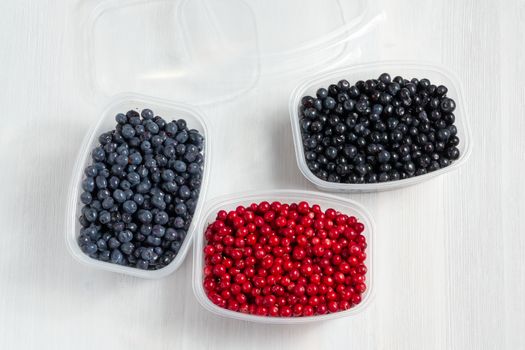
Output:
[{"xmin": 289, "ymin": 61, "xmax": 472, "ymax": 192}]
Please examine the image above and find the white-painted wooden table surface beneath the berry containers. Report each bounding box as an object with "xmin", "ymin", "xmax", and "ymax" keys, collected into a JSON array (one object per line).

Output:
[{"xmin": 0, "ymin": 0, "xmax": 525, "ymax": 349}]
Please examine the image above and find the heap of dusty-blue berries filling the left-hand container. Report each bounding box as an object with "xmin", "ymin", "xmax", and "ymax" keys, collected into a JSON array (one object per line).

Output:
[{"xmin": 78, "ymin": 109, "xmax": 204, "ymax": 270}]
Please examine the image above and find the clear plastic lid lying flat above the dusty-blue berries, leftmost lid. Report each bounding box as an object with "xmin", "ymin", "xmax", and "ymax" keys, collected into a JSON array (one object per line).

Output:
[{"xmin": 87, "ymin": 0, "xmax": 258, "ymax": 104}]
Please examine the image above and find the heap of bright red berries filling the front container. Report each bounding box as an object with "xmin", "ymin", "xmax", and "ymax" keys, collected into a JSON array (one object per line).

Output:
[{"xmin": 203, "ymin": 202, "xmax": 367, "ymax": 317}]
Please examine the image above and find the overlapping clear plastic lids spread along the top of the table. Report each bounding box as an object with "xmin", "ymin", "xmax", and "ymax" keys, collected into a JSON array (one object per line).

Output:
[{"xmin": 82, "ymin": 0, "xmax": 374, "ymax": 104}]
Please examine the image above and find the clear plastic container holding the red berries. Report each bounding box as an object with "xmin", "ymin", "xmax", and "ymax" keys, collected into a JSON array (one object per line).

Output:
[{"xmin": 193, "ymin": 190, "xmax": 374, "ymax": 324}]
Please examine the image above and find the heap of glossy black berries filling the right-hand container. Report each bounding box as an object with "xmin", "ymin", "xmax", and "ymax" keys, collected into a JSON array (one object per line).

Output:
[{"xmin": 300, "ymin": 73, "xmax": 459, "ymax": 183}]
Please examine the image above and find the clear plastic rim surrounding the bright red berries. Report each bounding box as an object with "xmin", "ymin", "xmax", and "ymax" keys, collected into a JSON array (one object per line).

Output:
[{"xmin": 192, "ymin": 189, "xmax": 375, "ymax": 324}]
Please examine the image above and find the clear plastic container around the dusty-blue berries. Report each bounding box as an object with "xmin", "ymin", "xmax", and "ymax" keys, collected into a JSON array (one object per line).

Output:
[{"xmin": 65, "ymin": 94, "xmax": 211, "ymax": 278}]
